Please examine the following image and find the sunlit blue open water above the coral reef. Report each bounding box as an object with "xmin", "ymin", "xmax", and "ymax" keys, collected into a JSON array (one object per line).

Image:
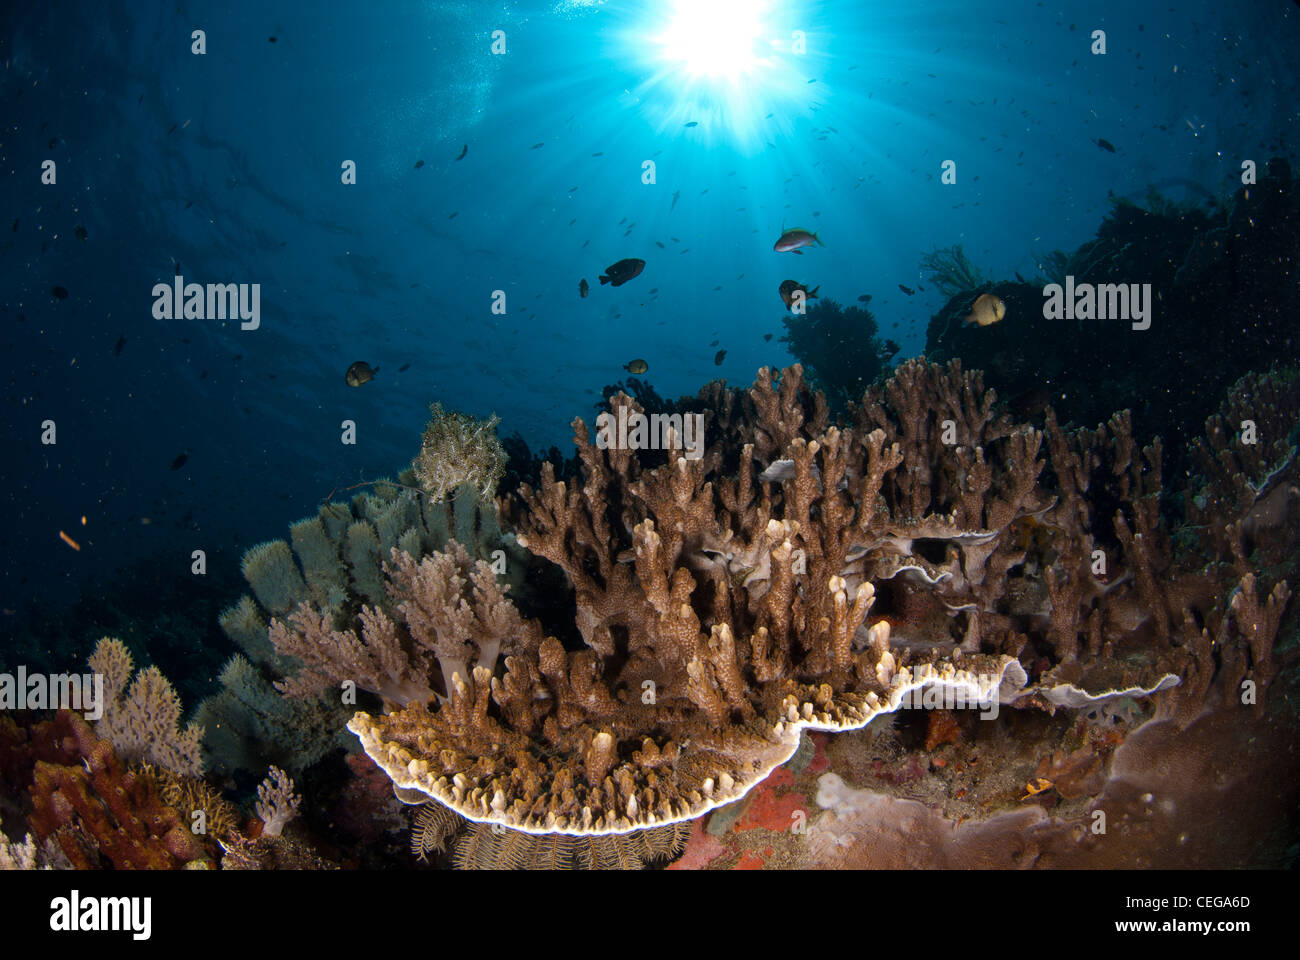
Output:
[{"xmin": 0, "ymin": 0, "xmax": 1300, "ymax": 613}]
